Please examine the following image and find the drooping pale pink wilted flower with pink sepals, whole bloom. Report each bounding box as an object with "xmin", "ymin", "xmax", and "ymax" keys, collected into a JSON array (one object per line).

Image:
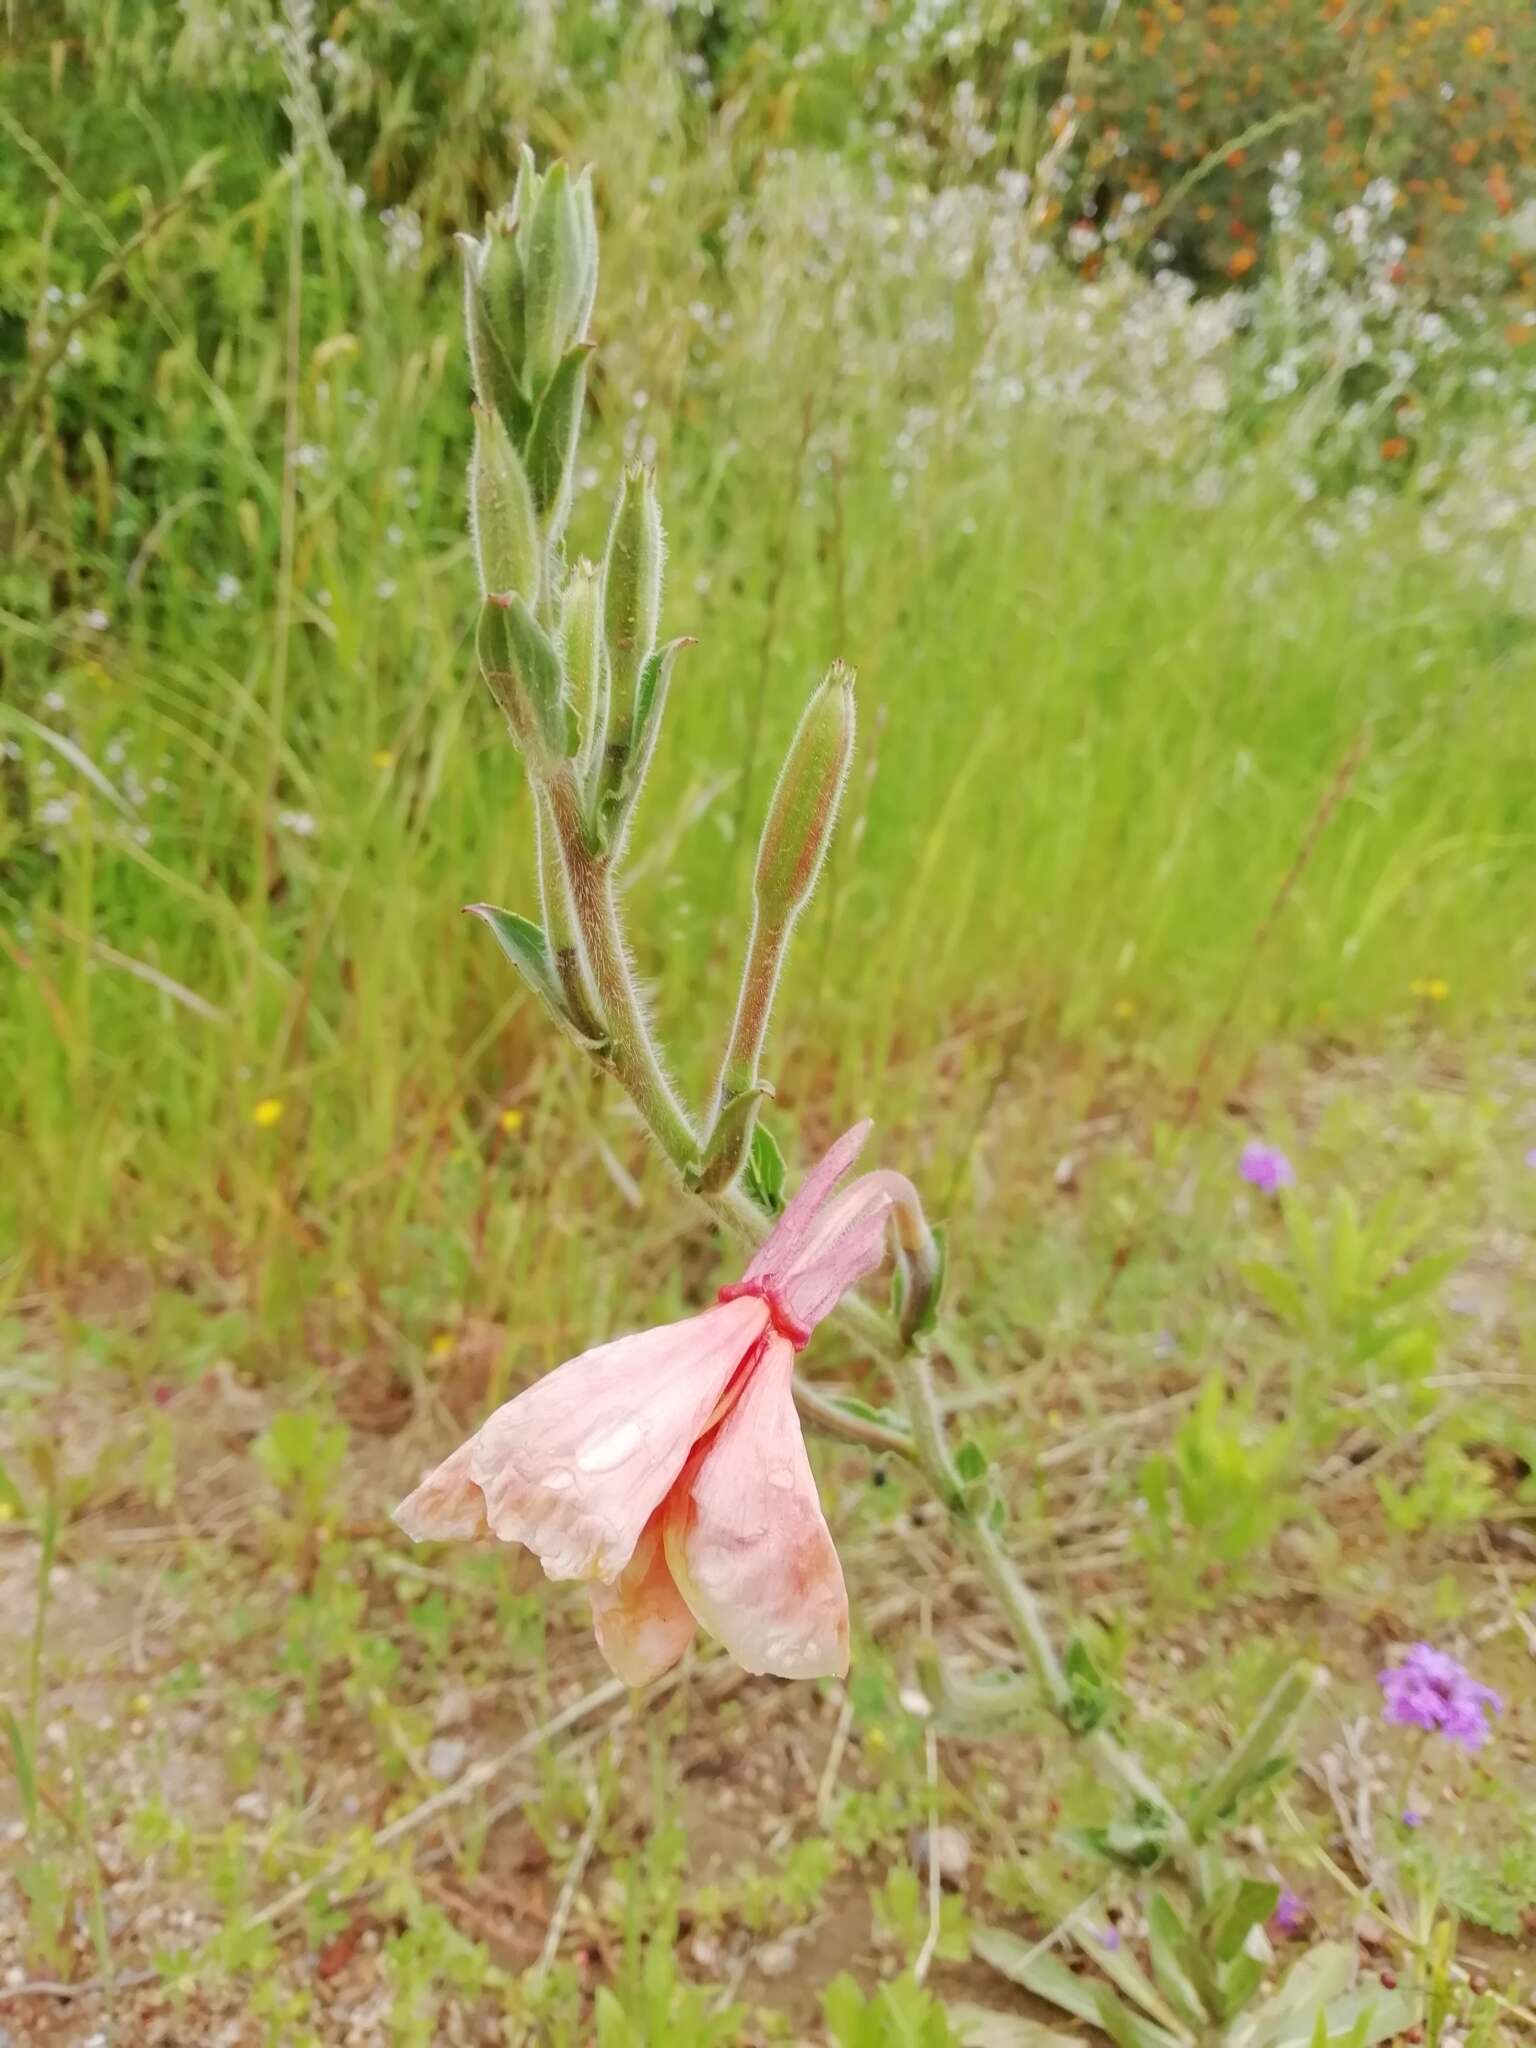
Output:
[{"xmin": 395, "ymin": 1122, "xmax": 915, "ymax": 1686}]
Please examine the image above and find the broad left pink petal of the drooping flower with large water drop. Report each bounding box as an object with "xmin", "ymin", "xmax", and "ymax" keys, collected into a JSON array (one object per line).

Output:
[{"xmin": 469, "ymin": 1296, "xmax": 768, "ymax": 1581}]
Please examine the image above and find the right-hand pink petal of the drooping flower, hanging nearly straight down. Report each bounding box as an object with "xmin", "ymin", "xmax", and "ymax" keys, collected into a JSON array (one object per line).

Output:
[{"xmin": 664, "ymin": 1337, "xmax": 848, "ymax": 1677}]
